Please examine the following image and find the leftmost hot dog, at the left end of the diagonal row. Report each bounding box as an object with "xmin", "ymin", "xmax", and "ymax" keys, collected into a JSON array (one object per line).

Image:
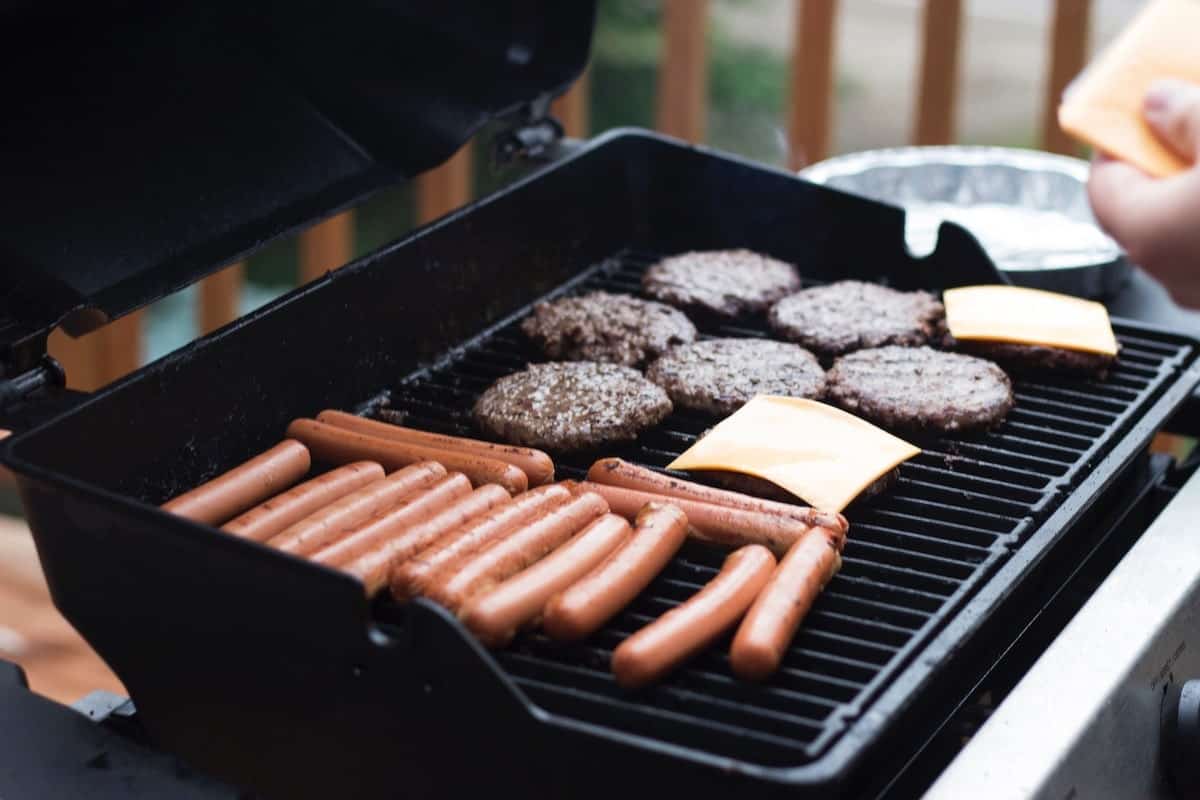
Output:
[{"xmin": 162, "ymin": 439, "xmax": 312, "ymax": 525}]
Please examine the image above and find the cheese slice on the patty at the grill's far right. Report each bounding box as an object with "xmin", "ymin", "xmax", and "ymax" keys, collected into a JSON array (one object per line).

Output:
[{"xmin": 942, "ymin": 285, "xmax": 1117, "ymax": 355}]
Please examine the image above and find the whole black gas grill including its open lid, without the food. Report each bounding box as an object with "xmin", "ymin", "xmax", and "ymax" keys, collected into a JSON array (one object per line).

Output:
[{"xmin": 7, "ymin": 0, "xmax": 1200, "ymax": 798}]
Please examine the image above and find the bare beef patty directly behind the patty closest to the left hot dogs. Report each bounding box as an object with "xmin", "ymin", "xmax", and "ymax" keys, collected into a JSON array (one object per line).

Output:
[{"xmin": 521, "ymin": 291, "xmax": 696, "ymax": 367}]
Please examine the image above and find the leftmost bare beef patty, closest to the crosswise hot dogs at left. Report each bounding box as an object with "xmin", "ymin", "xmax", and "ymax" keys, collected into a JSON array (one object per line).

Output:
[{"xmin": 474, "ymin": 361, "xmax": 671, "ymax": 451}]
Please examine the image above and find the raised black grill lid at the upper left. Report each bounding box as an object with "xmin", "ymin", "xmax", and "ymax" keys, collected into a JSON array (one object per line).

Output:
[{"xmin": 0, "ymin": 0, "xmax": 595, "ymax": 381}]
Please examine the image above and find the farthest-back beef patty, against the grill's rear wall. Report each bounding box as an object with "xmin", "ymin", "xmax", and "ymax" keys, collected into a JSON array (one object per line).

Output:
[{"xmin": 642, "ymin": 249, "xmax": 800, "ymax": 319}]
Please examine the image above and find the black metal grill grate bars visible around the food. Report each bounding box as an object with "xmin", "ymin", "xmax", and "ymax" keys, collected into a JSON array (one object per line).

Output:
[{"xmin": 374, "ymin": 252, "xmax": 1187, "ymax": 765}]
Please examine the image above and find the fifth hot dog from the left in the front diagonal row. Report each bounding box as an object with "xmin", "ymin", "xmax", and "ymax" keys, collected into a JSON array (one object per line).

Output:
[{"xmin": 338, "ymin": 483, "xmax": 512, "ymax": 595}]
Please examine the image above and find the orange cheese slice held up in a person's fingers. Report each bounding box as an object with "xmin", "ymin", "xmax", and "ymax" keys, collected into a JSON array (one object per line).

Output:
[{"xmin": 1058, "ymin": 0, "xmax": 1200, "ymax": 178}]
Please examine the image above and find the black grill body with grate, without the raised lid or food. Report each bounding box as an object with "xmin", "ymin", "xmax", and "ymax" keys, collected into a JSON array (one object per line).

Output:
[{"xmin": 2, "ymin": 132, "xmax": 1200, "ymax": 796}]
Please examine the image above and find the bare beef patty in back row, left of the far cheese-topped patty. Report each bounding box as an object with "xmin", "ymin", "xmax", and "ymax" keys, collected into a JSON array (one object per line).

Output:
[{"xmin": 768, "ymin": 281, "xmax": 946, "ymax": 356}]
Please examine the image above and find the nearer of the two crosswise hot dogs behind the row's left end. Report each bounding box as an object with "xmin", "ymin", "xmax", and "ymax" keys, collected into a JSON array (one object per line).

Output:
[{"xmin": 288, "ymin": 420, "xmax": 529, "ymax": 494}]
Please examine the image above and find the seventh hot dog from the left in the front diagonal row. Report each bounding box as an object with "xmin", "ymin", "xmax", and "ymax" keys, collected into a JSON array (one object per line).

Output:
[{"xmin": 427, "ymin": 492, "xmax": 608, "ymax": 613}]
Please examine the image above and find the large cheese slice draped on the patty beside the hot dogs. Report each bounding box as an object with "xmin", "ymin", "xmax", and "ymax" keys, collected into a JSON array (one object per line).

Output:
[{"xmin": 668, "ymin": 395, "xmax": 920, "ymax": 511}]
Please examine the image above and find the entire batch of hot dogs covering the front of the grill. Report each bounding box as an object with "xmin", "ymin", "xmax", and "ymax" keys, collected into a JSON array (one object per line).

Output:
[{"xmin": 163, "ymin": 411, "xmax": 847, "ymax": 687}]
